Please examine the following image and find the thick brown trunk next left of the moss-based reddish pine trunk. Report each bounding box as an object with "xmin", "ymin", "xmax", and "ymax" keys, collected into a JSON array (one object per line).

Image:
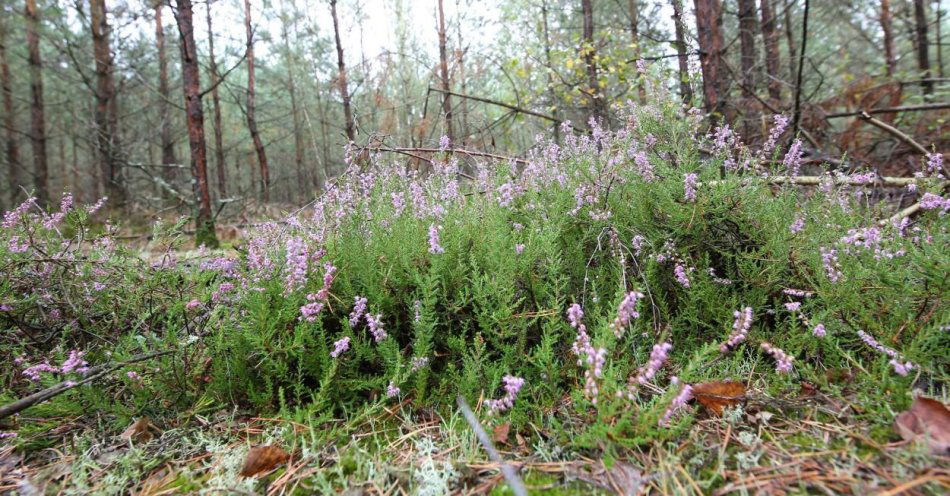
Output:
[{"xmin": 89, "ymin": 0, "xmax": 126, "ymax": 207}]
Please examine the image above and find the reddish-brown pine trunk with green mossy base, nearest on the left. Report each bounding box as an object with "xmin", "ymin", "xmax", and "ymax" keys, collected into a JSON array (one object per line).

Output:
[{"xmin": 175, "ymin": 0, "xmax": 218, "ymax": 248}]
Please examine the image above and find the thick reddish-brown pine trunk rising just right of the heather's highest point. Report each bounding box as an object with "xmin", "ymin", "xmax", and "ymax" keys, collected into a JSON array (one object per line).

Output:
[{"xmin": 694, "ymin": 0, "xmax": 724, "ymax": 122}]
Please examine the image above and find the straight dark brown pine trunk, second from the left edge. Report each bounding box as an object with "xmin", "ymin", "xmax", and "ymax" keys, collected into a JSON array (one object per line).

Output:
[{"xmin": 24, "ymin": 0, "xmax": 49, "ymax": 206}]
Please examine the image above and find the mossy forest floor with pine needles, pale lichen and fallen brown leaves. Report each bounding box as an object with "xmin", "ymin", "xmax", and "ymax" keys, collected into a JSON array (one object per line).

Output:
[{"xmin": 0, "ymin": 370, "xmax": 950, "ymax": 496}]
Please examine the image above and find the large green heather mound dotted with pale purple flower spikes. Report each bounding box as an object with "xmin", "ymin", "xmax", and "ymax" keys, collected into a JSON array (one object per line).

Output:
[{"xmin": 0, "ymin": 98, "xmax": 950, "ymax": 446}]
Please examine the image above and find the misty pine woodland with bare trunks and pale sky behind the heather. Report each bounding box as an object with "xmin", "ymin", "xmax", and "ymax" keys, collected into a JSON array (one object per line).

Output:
[{"xmin": 0, "ymin": 0, "xmax": 950, "ymax": 240}]
